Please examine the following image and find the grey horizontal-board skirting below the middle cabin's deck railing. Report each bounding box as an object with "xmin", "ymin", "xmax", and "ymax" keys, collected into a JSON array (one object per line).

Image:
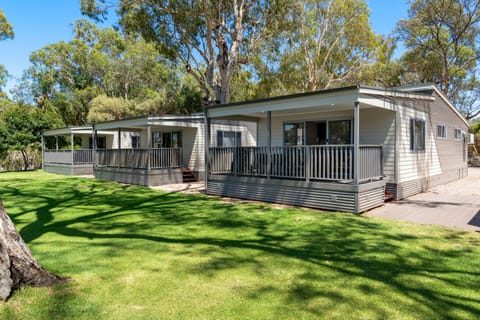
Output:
[{"xmin": 94, "ymin": 167, "xmax": 183, "ymax": 186}]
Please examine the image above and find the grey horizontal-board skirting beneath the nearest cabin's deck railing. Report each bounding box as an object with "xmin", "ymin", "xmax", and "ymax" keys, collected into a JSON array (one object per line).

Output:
[{"xmin": 206, "ymin": 175, "xmax": 385, "ymax": 213}]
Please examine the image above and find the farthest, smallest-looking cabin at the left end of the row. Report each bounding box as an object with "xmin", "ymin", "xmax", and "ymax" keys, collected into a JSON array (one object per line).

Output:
[{"xmin": 42, "ymin": 126, "xmax": 112, "ymax": 175}]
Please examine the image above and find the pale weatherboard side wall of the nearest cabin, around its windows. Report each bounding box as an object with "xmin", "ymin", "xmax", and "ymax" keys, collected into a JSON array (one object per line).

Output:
[{"xmin": 386, "ymin": 93, "xmax": 468, "ymax": 199}]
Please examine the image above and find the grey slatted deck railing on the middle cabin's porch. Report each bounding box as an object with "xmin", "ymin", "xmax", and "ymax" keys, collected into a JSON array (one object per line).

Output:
[{"xmin": 95, "ymin": 148, "xmax": 182, "ymax": 169}]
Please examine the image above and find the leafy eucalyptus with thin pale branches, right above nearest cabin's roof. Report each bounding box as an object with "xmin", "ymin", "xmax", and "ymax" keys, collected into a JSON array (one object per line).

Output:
[{"xmin": 253, "ymin": 0, "xmax": 383, "ymax": 92}]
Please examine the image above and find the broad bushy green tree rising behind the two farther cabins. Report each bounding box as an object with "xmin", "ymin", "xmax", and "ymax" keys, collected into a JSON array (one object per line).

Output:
[{"xmin": 22, "ymin": 20, "xmax": 195, "ymax": 125}]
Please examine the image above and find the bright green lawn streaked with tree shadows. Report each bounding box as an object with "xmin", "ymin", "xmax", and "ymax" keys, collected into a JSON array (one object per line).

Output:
[{"xmin": 0, "ymin": 171, "xmax": 480, "ymax": 319}]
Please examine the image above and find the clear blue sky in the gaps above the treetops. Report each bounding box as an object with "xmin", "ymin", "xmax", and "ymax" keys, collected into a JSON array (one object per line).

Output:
[{"xmin": 0, "ymin": 0, "xmax": 408, "ymax": 91}]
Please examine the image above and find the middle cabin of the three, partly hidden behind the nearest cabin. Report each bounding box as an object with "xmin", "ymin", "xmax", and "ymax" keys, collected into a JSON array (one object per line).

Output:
[{"xmin": 93, "ymin": 115, "xmax": 256, "ymax": 186}]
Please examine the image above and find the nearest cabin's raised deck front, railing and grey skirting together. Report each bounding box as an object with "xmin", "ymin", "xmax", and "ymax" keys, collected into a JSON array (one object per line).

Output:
[{"xmin": 206, "ymin": 145, "xmax": 385, "ymax": 213}]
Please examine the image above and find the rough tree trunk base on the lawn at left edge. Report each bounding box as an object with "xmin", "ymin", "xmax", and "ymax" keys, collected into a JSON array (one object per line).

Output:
[{"xmin": 0, "ymin": 200, "xmax": 68, "ymax": 300}]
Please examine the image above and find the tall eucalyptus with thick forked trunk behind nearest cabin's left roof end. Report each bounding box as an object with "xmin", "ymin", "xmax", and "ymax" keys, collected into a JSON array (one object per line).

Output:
[{"xmin": 82, "ymin": 0, "xmax": 289, "ymax": 104}]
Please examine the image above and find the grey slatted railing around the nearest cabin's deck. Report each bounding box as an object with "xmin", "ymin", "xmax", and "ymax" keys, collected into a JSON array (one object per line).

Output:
[{"xmin": 209, "ymin": 145, "xmax": 383, "ymax": 182}]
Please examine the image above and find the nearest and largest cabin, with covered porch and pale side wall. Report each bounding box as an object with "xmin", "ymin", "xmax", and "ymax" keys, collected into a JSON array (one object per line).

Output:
[{"xmin": 205, "ymin": 84, "xmax": 468, "ymax": 213}]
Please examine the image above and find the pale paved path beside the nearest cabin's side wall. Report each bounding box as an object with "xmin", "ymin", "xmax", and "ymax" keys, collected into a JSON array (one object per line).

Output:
[{"xmin": 366, "ymin": 168, "xmax": 480, "ymax": 232}]
